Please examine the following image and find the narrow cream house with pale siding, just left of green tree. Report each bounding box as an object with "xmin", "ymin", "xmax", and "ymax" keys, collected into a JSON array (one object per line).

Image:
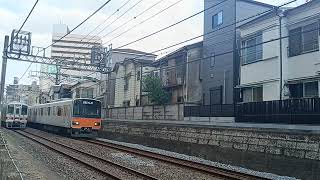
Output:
[{"xmin": 113, "ymin": 59, "xmax": 154, "ymax": 107}]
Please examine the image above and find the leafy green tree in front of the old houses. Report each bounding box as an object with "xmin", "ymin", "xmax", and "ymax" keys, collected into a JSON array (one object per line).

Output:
[{"xmin": 143, "ymin": 75, "xmax": 169, "ymax": 105}]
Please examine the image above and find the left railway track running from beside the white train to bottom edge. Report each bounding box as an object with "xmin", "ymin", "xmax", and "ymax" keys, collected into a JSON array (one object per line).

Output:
[{"xmin": 15, "ymin": 130, "xmax": 157, "ymax": 180}]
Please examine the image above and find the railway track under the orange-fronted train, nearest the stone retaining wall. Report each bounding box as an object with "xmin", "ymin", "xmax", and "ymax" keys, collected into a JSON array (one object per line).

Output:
[{"xmin": 86, "ymin": 140, "xmax": 267, "ymax": 180}]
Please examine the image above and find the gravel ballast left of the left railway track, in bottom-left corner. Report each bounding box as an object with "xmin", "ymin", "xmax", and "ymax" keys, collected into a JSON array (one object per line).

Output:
[{"xmin": 3, "ymin": 129, "xmax": 106, "ymax": 180}]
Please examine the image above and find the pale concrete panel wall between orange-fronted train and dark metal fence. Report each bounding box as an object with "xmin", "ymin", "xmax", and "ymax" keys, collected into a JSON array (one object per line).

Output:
[{"xmin": 109, "ymin": 104, "xmax": 184, "ymax": 121}]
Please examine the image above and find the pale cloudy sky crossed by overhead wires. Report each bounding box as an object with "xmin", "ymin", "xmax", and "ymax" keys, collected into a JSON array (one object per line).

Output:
[{"xmin": 0, "ymin": 0, "xmax": 305, "ymax": 84}]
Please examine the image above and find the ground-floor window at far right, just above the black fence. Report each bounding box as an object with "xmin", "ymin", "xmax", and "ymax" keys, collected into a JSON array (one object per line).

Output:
[{"xmin": 289, "ymin": 81, "xmax": 319, "ymax": 98}]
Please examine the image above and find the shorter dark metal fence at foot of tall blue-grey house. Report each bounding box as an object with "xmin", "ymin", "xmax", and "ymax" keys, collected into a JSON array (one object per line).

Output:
[{"xmin": 184, "ymin": 104, "xmax": 234, "ymax": 117}]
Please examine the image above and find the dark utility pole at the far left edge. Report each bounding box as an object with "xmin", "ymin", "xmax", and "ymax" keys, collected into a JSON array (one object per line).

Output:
[{"xmin": 0, "ymin": 36, "xmax": 9, "ymax": 111}]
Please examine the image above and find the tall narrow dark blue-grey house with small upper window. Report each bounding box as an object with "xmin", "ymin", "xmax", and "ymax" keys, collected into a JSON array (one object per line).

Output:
[{"xmin": 200, "ymin": 0, "xmax": 274, "ymax": 105}]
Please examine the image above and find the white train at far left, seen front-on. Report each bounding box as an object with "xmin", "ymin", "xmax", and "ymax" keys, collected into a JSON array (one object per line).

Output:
[{"xmin": 1, "ymin": 102, "xmax": 28, "ymax": 129}]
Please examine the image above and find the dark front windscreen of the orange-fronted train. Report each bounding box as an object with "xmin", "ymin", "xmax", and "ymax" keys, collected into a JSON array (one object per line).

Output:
[{"xmin": 73, "ymin": 99, "xmax": 101, "ymax": 118}]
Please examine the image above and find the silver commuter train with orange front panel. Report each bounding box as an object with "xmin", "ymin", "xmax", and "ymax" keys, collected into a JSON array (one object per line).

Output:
[{"xmin": 28, "ymin": 98, "xmax": 101, "ymax": 137}]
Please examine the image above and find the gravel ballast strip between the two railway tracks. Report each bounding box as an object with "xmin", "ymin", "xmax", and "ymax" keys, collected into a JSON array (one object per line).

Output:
[{"xmin": 26, "ymin": 129, "xmax": 225, "ymax": 180}]
